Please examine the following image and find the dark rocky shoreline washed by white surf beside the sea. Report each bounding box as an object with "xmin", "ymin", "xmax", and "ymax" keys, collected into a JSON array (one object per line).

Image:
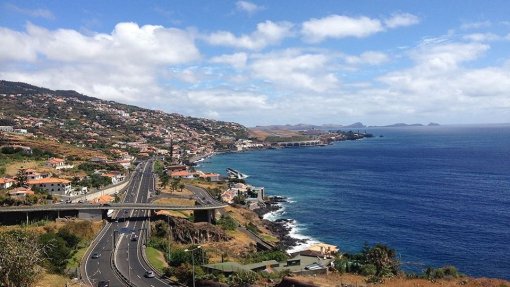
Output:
[{"xmin": 254, "ymin": 196, "xmax": 306, "ymax": 251}]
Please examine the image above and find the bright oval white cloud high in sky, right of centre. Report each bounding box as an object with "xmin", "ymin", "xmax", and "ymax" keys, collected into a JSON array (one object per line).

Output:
[{"xmin": 301, "ymin": 15, "xmax": 383, "ymax": 43}]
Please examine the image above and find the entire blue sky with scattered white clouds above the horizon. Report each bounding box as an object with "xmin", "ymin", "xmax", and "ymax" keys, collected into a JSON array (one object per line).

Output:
[{"xmin": 0, "ymin": 0, "xmax": 510, "ymax": 126}]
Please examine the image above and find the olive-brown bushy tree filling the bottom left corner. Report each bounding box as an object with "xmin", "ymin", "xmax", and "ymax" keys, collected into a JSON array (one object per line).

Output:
[{"xmin": 0, "ymin": 231, "xmax": 47, "ymax": 287}]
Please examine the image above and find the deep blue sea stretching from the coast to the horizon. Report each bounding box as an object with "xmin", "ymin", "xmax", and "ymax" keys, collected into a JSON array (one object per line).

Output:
[{"xmin": 200, "ymin": 125, "xmax": 510, "ymax": 279}]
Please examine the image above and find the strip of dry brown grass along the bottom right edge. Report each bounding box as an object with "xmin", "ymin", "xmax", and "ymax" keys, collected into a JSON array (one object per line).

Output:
[{"xmin": 288, "ymin": 273, "xmax": 510, "ymax": 287}]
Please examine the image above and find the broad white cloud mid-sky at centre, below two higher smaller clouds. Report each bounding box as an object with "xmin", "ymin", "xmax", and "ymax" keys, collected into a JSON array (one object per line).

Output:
[{"xmin": 250, "ymin": 50, "xmax": 339, "ymax": 92}]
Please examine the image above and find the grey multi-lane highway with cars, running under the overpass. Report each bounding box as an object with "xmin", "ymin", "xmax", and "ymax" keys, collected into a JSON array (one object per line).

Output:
[{"xmin": 84, "ymin": 161, "xmax": 169, "ymax": 287}]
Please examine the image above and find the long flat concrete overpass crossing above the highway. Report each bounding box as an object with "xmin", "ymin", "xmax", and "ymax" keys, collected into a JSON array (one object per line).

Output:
[{"xmin": 0, "ymin": 202, "xmax": 228, "ymax": 213}]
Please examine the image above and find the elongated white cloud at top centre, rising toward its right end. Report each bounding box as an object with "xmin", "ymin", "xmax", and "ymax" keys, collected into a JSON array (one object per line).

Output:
[{"xmin": 206, "ymin": 21, "xmax": 293, "ymax": 50}]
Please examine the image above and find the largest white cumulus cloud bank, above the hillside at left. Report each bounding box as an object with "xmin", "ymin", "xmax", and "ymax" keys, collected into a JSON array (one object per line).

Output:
[{"xmin": 0, "ymin": 23, "xmax": 200, "ymax": 101}]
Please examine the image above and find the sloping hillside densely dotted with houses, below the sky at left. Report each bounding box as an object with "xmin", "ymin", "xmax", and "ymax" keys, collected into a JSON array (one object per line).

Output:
[{"xmin": 0, "ymin": 81, "xmax": 248, "ymax": 160}]
